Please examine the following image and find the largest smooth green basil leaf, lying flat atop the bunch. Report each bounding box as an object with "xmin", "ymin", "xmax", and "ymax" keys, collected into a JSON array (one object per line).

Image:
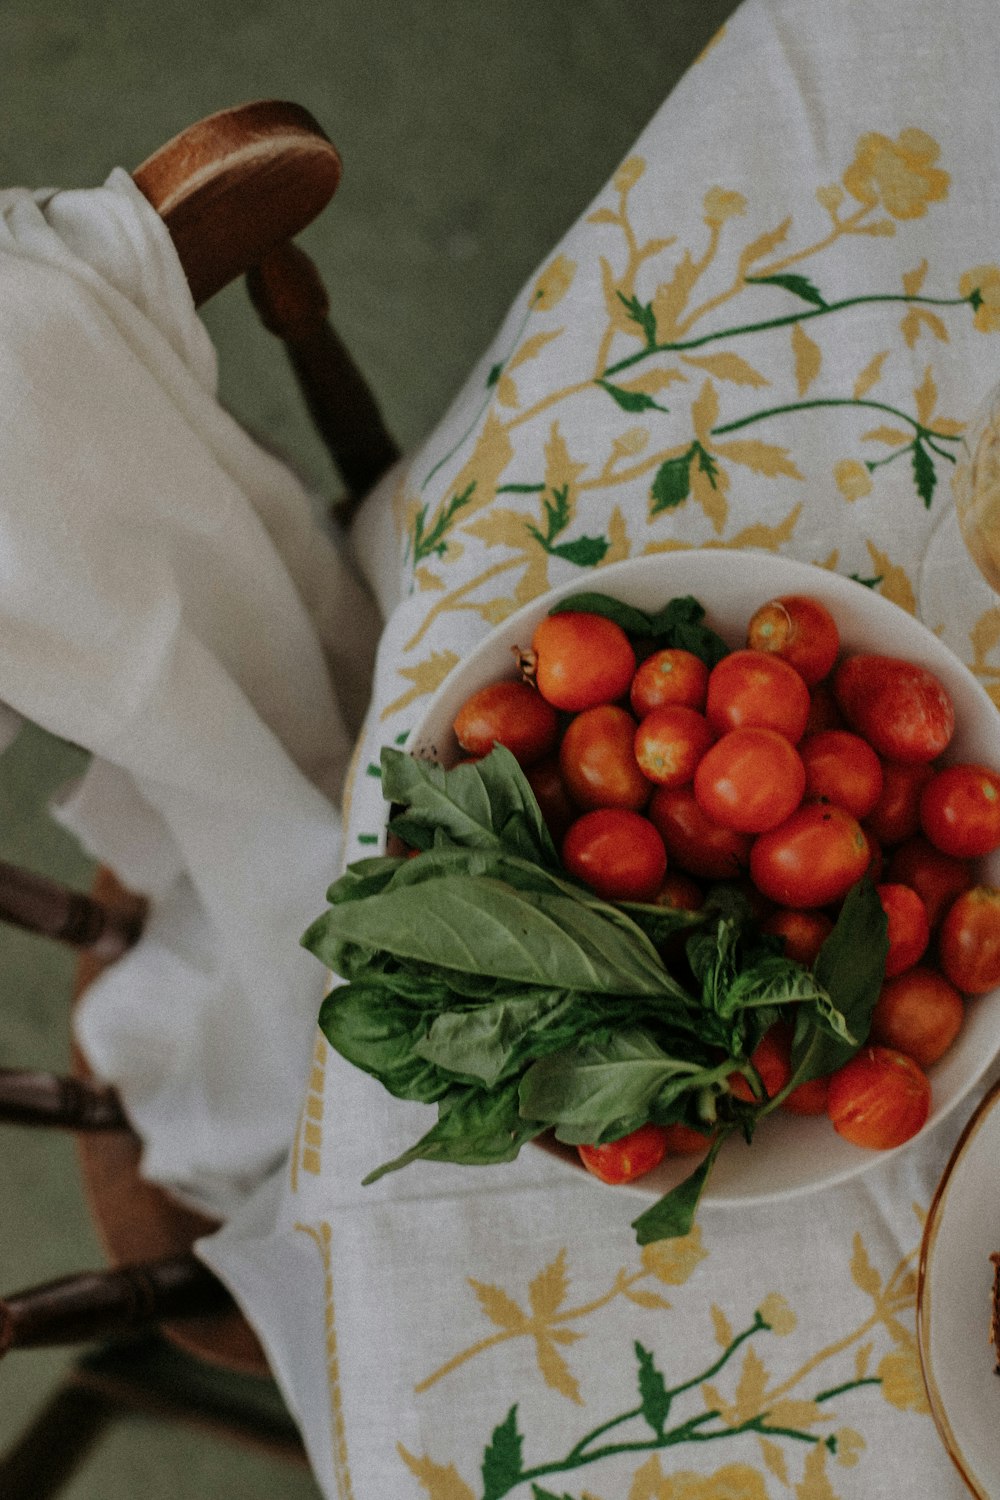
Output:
[{"xmin": 310, "ymin": 855, "xmax": 678, "ymax": 995}]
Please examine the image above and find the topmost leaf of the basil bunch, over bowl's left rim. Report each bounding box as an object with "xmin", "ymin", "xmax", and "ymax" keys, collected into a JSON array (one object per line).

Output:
[{"xmin": 382, "ymin": 746, "xmax": 559, "ymax": 869}]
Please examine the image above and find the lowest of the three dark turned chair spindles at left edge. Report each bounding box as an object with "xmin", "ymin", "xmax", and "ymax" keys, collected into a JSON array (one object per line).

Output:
[{"xmin": 0, "ymin": 1254, "xmax": 234, "ymax": 1356}]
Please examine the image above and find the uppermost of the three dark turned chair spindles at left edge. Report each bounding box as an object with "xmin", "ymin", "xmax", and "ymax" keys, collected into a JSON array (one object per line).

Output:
[{"xmin": 0, "ymin": 863, "xmax": 147, "ymax": 963}]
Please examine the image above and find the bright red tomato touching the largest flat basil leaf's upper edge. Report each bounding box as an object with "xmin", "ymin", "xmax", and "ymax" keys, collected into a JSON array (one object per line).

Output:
[{"xmin": 562, "ymin": 807, "xmax": 667, "ymax": 902}]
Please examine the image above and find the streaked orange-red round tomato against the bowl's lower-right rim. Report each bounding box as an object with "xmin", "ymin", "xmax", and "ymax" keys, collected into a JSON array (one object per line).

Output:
[{"xmin": 826, "ymin": 1047, "xmax": 931, "ymax": 1151}]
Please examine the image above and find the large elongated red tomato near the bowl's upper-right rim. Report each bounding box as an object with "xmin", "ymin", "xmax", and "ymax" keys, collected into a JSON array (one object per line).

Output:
[{"xmin": 834, "ymin": 656, "xmax": 955, "ymax": 765}]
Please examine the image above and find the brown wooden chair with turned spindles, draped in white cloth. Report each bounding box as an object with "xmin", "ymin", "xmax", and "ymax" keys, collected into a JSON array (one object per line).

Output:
[{"xmin": 0, "ymin": 101, "xmax": 397, "ymax": 1373}]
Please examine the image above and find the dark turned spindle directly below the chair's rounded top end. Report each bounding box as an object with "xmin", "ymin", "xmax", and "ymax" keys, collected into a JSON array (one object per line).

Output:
[{"xmin": 246, "ymin": 243, "xmax": 399, "ymax": 522}]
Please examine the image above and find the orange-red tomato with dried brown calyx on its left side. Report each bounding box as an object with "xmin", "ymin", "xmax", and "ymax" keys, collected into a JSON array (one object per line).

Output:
[{"xmin": 531, "ymin": 609, "xmax": 636, "ymax": 714}]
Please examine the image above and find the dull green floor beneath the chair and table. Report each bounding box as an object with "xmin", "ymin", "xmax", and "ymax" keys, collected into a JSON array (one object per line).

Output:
[{"xmin": 0, "ymin": 0, "xmax": 735, "ymax": 1500}]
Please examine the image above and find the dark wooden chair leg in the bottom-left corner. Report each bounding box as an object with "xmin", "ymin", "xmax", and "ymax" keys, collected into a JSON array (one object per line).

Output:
[{"xmin": 0, "ymin": 1376, "xmax": 115, "ymax": 1500}]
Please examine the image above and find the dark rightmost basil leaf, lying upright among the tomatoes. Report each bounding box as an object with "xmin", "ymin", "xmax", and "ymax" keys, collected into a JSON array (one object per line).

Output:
[{"xmin": 792, "ymin": 876, "xmax": 889, "ymax": 1086}]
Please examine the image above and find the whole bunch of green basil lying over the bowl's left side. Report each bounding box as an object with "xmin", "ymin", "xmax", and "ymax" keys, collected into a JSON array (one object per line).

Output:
[{"xmin": 303, "ymin": 738, "xmax": 886, "ymax": 1244}]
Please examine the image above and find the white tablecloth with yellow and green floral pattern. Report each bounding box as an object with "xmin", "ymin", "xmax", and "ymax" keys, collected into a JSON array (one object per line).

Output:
[{"xmin": 204, "ymin": 0, "xmax": 1000, "ymax": 1500}]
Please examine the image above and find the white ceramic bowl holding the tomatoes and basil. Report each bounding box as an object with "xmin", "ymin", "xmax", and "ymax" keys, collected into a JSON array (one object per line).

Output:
[{"xmin": 408, "ymin": 549, "xmax": 1000, "ymax": 1205}]
